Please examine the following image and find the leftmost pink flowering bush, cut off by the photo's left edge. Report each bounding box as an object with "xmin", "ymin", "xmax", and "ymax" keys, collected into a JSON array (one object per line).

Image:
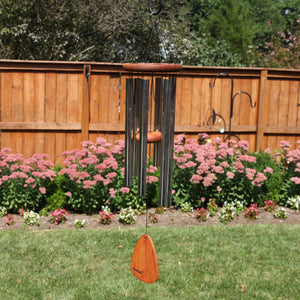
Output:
[{"xmin": 0, "ymin": 148, "xmax": 56, "ymax": 213}]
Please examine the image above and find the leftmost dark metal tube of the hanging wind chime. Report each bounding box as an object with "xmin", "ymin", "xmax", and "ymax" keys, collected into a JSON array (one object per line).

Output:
[{"xmin": 125, "ymin": 78, "xmax": 135, "ymax": 186}]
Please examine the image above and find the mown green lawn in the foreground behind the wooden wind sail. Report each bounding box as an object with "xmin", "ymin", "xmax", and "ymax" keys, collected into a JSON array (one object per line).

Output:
[{"xmin": 0, "ymin": 225, "xmax": 300, "ymax": 300}]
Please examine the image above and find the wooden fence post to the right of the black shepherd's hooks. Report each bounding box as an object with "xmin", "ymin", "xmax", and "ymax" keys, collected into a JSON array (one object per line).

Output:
[{"xmin": 255, "ymin": 70, "xmax": 268, "ymax": 151}]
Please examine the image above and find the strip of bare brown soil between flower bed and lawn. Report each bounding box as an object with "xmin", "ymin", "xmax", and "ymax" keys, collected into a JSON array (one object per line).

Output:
[{"xmin": 0, "ymin": 208, "xmax": 300, "ymax": 230}]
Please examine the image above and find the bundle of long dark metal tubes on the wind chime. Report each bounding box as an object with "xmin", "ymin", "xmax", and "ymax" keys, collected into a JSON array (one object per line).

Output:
[{"xmin": 125, "ymin": 71, "xmax": 176, "ymax": 207}]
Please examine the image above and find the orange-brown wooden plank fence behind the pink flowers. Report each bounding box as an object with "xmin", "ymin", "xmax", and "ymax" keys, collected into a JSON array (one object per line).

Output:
[{"xmin": 0, "ymin": 60, "xmax": 300, "ymax": 163}]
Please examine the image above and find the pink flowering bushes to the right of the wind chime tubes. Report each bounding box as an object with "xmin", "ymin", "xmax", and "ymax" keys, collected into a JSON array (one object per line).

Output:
[{"xmin": 173, "ymin": 135, "xmax": 300, "ymax": 207}]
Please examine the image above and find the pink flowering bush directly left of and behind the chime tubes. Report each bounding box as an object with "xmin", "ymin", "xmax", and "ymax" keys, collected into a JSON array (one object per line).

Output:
[{"xmin": 59, "ymin": 137, "xmax": 158, "ymax": 213}]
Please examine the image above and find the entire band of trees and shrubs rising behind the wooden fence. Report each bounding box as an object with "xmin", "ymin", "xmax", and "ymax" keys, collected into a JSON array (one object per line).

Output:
[{"xmin": 0, "ymin": 0, "xmax": 300, "ymax": 67}]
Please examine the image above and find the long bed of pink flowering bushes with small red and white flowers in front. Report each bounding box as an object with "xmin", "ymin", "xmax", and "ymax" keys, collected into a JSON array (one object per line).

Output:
[{"xmin": 0, "ymin": 134, "xmax": 300, "ymax": 228}]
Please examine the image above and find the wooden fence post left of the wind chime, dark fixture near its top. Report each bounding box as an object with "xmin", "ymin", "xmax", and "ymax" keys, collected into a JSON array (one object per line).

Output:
[{"xmin": 81, "ymin": 65, "xmax": 91, "ymax": 141}]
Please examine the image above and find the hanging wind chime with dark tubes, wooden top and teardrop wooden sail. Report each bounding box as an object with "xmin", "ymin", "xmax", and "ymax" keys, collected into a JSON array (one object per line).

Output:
[{"xmin": 123, "ymin": 0, "xmax": 182, "ymax": 283}]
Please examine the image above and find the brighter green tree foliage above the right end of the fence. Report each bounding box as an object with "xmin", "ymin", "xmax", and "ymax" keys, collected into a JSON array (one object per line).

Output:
[{"xmin": 186, "ymin": 0, "xmax": 300, "ymax": 68}]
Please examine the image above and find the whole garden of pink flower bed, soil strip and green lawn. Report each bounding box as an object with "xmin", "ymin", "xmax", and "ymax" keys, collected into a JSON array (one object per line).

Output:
[{"xmin": 0, "ymin": 134, "xmax": 300, "ymax": 299}]
